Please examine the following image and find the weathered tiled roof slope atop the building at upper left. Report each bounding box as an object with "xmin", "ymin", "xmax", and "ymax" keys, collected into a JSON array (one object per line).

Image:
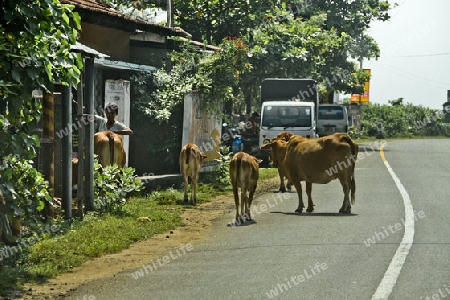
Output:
[{"xmin": 60, "ymin": 0, "xmax": 189, "ymax": 37}]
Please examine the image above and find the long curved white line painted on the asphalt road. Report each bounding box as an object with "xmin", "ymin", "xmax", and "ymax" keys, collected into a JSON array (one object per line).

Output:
[{"xmin": 372, "ymin": 147, "xmax": 414, "ymax": 300}]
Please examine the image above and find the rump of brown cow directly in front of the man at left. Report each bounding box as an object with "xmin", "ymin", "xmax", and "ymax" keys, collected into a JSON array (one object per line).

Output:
[{"xmin": 94, "ymin": 131, "xmax": 127, "ymax": 168}]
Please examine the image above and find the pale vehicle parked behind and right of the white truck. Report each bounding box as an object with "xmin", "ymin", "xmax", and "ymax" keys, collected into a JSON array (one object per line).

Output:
[{"xmin": 317, "ymin": 103, "xmax": 348, "ymax": 136}]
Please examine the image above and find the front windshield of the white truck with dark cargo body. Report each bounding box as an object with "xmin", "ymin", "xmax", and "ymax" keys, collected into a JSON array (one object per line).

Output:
[{"xmin": 261, "ymin": 105, "xmax": 311, "ymax": 128}]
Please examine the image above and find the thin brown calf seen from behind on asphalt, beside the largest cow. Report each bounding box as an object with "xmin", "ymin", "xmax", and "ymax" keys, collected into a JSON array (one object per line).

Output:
[{"xmin": 230, "ymin": 152, "xmax": 260, "ymax": 223}]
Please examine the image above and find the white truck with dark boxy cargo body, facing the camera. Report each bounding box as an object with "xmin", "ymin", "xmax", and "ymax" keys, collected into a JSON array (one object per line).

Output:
[{"xmin": 259, "ymin": 78, "xmax": 319, "ymax": 146}]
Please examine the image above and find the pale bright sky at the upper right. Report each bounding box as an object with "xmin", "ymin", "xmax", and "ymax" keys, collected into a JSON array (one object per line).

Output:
[{"xmin": 363, "ymin": 0, "xmax": 450, "ymax": 109}]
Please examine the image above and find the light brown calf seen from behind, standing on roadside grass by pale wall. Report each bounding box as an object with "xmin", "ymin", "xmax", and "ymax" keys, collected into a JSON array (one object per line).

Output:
[{"xmin": 180, "ymin": 143, "xmax": 206, "ymax": 205}]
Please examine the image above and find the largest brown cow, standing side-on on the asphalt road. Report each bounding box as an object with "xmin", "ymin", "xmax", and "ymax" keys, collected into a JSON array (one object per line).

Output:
[{"xmin": 283, "ymin": 133, "xmax": 358, "ymax": 214}]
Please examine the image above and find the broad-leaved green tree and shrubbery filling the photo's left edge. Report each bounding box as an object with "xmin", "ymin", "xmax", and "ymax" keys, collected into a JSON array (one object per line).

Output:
[{"xmin": 0, "ymin": 0, "xmax": 82, "ymax": 229}]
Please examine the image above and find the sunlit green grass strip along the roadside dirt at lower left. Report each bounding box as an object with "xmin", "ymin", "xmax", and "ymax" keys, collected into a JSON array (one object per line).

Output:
[{"xmin": 24, "ymin": 197, "xmax": 182, "ymax": 280}]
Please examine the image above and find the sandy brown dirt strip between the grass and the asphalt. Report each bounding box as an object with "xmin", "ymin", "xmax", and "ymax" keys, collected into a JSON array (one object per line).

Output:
[{"xmin": 22, "ymin": 178, "xmax": 279, "ymax": 300}]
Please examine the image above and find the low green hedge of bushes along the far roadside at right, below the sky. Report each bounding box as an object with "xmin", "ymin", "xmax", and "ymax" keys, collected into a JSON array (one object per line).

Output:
[{"xmin": 361, "ymin": 98, "xmax": 450, "ymax": 138}]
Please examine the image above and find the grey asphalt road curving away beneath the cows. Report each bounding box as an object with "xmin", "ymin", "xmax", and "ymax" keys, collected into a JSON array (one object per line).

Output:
[{"xmin": 71, "ymin": 139, "xmax": 450, "ymax": 300}]
